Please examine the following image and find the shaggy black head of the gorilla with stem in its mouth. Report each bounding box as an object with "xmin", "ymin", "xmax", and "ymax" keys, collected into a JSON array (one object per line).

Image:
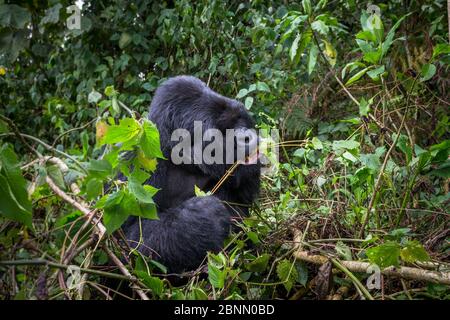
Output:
[{"xmin": 150, "ymin": 76, "xmax": 260, "ymax": 186}]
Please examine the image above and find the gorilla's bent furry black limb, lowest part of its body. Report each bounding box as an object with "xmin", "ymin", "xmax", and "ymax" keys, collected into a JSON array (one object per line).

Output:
[{"xmin": 124, "ymin": 196, "xmax": 231, "ymax": 273}]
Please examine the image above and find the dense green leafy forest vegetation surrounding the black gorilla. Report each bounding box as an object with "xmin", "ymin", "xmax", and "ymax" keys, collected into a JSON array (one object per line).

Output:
[{"xmin": 0, "ymin": 0, "xmax": 450, "ymax": 299}]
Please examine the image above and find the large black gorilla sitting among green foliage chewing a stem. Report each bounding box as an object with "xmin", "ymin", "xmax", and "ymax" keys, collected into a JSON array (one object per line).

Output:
[{"xmin": 123, "ymin": 76, "xmax": 260, "ymax": 272}]
